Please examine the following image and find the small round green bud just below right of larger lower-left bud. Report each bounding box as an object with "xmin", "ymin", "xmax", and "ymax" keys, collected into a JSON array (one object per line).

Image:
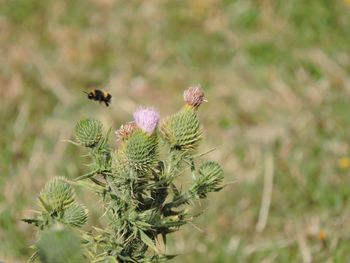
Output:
[{"xmin": 62, "ymin": 203, "xmax": 88, "ymax": 227}]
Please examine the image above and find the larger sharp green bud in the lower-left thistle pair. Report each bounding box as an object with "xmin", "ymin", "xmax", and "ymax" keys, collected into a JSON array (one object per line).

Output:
[{"xmin": 39, "ymin": 177, "xmax": 74, "ymax": 211}]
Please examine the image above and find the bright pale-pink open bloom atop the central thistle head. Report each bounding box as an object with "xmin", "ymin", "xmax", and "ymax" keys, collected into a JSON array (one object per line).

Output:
[{"xmin": 133, "ymin": 107, "xmax": 160, "ymax": 134}]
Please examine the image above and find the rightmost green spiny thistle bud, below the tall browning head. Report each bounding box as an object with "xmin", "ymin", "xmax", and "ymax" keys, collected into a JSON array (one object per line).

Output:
[{"xmin": 192, "ymin": 161, "xmax": 224, "ymax": 198}]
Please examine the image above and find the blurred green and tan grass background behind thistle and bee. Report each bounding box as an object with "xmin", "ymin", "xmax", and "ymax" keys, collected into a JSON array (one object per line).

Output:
[{"xmin": 0, "ymin": 0, "xmax": 350, "ymax": 263}]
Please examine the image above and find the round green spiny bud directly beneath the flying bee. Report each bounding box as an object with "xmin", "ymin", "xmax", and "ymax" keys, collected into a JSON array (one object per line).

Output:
[{"xmin": 75, "ymin": 118, "xmax": 102, "ymax": 147}]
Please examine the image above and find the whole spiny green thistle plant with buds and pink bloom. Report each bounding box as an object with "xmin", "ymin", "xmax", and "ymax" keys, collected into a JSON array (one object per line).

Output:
[{"xmin": 24, "ymin": 87, "xmax": 224, "ymax": 263}]
